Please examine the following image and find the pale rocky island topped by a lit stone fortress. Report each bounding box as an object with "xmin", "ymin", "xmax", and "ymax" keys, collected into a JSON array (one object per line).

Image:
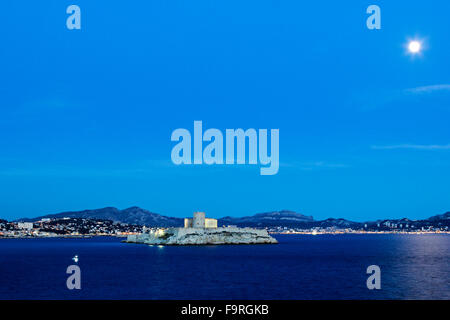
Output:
[{"xmin": 124, "ymin": 212, "xmax": 278, "ymax": 245}]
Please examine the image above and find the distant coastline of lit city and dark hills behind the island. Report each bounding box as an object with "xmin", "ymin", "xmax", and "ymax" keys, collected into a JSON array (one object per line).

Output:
[{"xmin": 0, "ymin": 207, "xmax": 450, "ymax": 238}]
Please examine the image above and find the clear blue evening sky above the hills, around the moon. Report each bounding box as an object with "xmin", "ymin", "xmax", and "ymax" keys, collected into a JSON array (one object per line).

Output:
[{"xmin": 0, "ymin": 0, "xmax": 450, "ymax": 221}]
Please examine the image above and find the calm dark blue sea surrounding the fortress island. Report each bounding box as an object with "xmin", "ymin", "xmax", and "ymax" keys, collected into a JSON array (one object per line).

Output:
[{"xmin": 0, "ymin": 235, "xmax": 450, "ymax": 299}]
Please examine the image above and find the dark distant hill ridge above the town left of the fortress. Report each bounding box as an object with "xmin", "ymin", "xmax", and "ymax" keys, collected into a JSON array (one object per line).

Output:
[{"xmin": 18, "ymin": 207, "xmax": 183, "ymax": 227}]
